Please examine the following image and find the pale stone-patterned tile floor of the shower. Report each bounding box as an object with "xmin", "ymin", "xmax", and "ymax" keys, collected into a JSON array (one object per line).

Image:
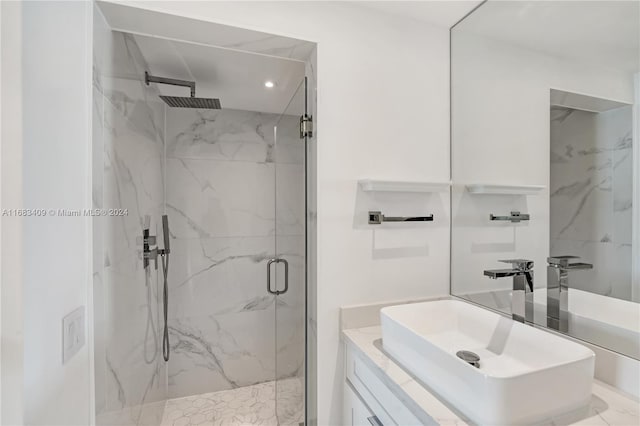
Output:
[{"xmin": 162, "ymin": 378, "xmax": 303, "ymax": 426}]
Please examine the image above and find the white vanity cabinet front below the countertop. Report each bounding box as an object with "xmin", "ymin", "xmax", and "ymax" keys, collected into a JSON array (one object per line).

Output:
[{"xmin": 343, "ymin": 345, "xmax": 428, "ymax": 426}]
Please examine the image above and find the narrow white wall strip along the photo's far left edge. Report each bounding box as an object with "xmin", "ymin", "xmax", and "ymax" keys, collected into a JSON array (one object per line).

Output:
[{"xmin": 0, "ymin": 2, "xmax": 23, "ymax": 425}]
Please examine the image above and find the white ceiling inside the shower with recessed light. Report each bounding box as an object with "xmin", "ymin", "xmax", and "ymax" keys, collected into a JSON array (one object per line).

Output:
[{"xmin": 134, "ymin": 35, "xmax": 304, "ymax": 114}]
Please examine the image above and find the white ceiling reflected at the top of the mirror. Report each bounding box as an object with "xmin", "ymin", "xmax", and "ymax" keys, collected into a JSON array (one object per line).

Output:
[{"xmin": 454, "ymin": 0, "xmax": 640, "ymax": 72}]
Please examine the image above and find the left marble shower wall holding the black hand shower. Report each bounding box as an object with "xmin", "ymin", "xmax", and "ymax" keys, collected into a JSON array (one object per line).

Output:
[{"xmin": 92, "ymin": 8, "xmax": 167, "ymax": 425}]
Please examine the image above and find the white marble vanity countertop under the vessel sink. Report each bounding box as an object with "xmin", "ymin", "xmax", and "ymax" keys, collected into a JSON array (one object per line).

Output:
[{"xmin": 342, "ymin": 326, "xmax": 640, "ymax": 426}]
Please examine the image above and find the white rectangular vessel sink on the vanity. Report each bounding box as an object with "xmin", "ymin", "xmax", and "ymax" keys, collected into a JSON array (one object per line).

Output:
[{"xmin": 380, "ymin": 300, "xmax": 595, "ymax": 425}]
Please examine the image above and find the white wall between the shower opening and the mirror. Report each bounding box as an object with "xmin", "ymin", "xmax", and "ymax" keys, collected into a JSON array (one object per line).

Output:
[{"xmin": 114, "ymin": 2, "xmax": 456, "ymax": 425}]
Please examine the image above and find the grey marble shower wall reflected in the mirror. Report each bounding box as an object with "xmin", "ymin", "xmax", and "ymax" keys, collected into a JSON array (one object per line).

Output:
[{"xmin": 550, "ymin": 106, "xmax": 633, "ymax": 300}]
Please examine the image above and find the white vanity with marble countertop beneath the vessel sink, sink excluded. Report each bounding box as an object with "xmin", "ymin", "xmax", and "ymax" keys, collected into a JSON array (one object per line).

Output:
[{"xmin": 336, "ymin": 317, "xmax": 640, "ymax": 426}]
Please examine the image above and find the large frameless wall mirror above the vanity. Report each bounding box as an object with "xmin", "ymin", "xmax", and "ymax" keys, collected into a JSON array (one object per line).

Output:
[{"xmin": 451, "ymin": 0, "xmax": 640, "ymax": 359}]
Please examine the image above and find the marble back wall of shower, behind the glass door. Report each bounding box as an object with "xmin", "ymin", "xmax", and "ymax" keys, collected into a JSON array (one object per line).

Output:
[{"xmin": 166, "ymin": 107, "xmax": 305, "ymax": 398}]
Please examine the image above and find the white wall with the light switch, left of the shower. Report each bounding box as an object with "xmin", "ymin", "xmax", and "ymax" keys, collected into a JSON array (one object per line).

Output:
[{"xmin": 21, "ymin": 2, "xmax": 92, "ymax": 425}]
